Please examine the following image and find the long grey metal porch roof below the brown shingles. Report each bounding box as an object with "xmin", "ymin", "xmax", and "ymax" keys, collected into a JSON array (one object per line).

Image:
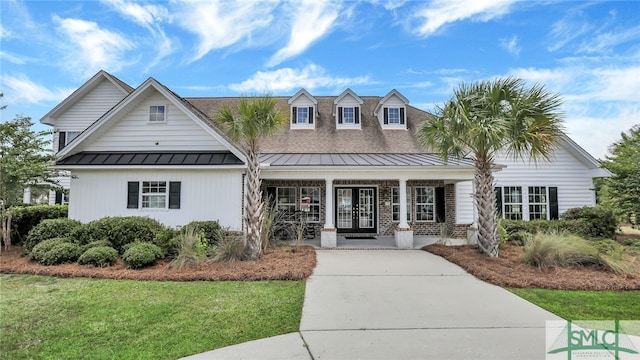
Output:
[{"xmin": 260, "ymin": 153, "xmax": 473, "ymax": 166}]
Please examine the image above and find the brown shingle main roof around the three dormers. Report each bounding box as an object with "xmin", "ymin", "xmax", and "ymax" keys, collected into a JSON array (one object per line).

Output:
[{"xmin": 185, "ymin": 96, "xmax": 432, "ymax": 154}]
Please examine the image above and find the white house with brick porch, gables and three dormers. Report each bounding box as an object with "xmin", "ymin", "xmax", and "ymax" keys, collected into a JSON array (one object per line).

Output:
[{"xmin": 41, "ymin": 71, "xmax": 603, "ymax": 247}]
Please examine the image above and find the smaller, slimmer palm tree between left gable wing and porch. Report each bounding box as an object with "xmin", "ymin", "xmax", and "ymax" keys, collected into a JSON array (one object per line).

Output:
[{"xmin": 218, "ymin": 95, "xmax": 286, "ymax": 259}]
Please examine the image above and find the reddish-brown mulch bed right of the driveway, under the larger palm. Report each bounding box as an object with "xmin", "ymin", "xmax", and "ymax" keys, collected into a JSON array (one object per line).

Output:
[{"xmin": 423, "ymin": 244, "xmax": 640, "ymax": 290}]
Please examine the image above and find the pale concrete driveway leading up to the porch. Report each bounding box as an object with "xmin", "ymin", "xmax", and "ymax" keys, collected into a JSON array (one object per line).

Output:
[{"xmin": 188, "ymin": 250, "xmax": 559, "ymax": 360}]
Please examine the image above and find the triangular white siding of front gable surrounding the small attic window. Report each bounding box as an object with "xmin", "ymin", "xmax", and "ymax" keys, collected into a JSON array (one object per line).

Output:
[{"xmin": 86, "ymin": 92, "xmax": 227, "ymax": 151}]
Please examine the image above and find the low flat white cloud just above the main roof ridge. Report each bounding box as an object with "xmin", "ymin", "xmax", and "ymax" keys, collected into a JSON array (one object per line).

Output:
[{"xmin": 229, "ymin": 64, "xmax": 371, "ymax": 93}]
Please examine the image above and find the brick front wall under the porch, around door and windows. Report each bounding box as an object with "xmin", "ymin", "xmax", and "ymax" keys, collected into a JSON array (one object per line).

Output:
[{"xmin": 262, "ymin": 180, "xmax": 469, "ymax": 238}]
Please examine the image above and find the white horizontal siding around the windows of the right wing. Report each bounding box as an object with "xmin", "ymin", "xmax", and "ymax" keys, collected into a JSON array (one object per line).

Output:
[{"xmin": 494, "ymin": 148, "xmax": 595, "ymax": 219}]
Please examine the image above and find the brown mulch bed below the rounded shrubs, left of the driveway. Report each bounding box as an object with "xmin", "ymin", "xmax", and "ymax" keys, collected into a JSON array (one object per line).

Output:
[{"xmin": 0, "ymin": 245, "xmax": 316, "ymax": 281}]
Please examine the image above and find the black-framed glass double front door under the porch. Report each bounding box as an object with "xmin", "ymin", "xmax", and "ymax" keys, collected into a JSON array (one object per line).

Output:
[{"xmin": 336, "ymin": 187, "xmax": 377, "ymax": 233}]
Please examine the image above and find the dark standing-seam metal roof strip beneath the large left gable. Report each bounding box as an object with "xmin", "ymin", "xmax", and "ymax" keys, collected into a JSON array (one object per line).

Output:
[{"xmin": 56, "ymin": 152, "xmax": 243, "ymax": 166}]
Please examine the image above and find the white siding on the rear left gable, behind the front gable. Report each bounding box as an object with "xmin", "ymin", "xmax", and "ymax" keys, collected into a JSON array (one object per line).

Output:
[{"xmin": 54, "ymin": 79, "xmax": 126, "ymax": 134}]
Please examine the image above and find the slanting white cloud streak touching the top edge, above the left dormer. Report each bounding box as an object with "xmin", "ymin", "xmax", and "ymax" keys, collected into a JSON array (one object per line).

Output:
[{"xmin": 268, "ymin": 0, "xmax": 340, "ymax": 66}]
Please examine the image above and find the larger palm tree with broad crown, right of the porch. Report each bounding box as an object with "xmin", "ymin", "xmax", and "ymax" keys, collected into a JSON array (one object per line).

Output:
[{"xmin": 420, "ymin": 77, "xmax": 563, "ymax": 256}]
